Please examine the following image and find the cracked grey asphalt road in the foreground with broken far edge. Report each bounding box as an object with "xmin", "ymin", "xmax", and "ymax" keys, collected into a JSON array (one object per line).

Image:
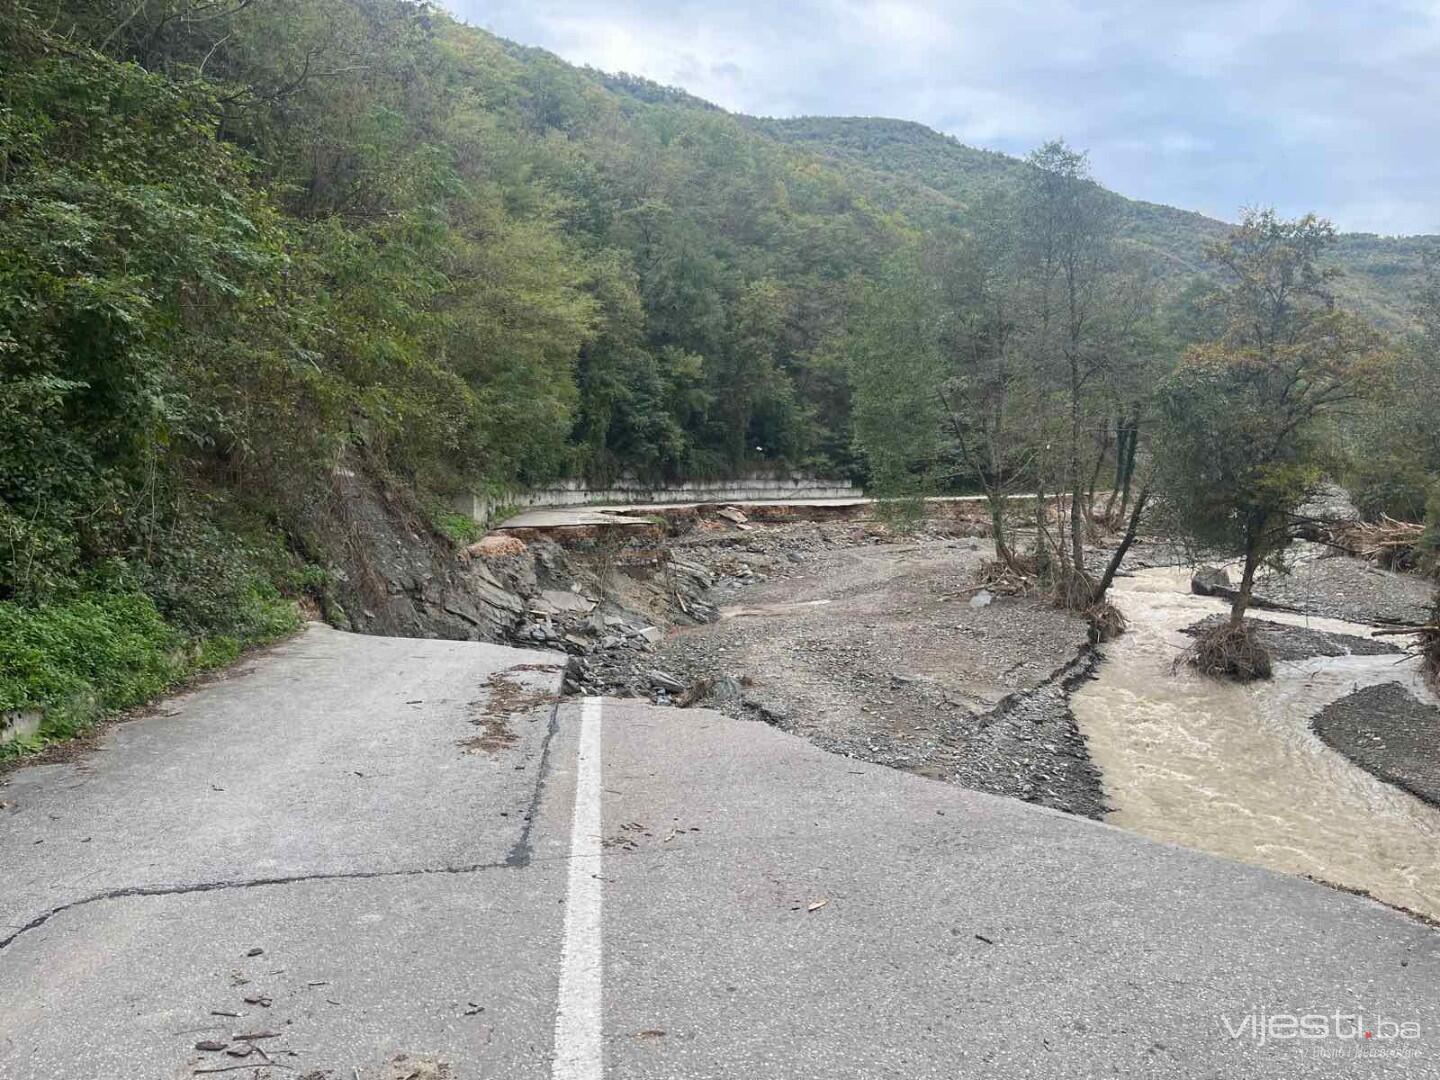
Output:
[{"xmin": 0, "ymin": 628, "xmax": 1440, "ymax": 1080}]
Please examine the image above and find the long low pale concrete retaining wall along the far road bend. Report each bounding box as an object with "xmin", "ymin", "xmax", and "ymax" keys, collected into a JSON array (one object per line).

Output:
[{"xmin": 455, "ymin": 477, "xmax": 864, "ymax": 524}]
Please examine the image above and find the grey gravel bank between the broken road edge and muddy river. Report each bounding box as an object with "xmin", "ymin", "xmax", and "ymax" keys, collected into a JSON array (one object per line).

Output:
[{"xmin": 630, "ymin": 526, "xmax": 1104, "ymax": 816}]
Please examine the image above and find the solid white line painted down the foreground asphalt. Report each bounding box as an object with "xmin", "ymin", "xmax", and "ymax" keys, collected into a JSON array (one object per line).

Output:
[{"xmin": 550, "ymin": 697, "xmax": 603, "ymax": 1080}]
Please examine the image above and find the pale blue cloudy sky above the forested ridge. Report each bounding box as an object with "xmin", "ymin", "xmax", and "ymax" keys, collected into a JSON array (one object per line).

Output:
[{"xmin": 445, "ymin": 0, "xmax": 1440, "ymax": 233}]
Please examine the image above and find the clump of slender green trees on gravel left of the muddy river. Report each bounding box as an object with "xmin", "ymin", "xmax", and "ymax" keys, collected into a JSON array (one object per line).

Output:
[{"xmin": 850, "ymin": 141, "xmax": 1176, "ymax": 611}]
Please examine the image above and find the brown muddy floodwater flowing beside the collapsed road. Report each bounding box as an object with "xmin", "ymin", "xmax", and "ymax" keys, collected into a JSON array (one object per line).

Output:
[{"xmin": 1071, "ymin": 569, "xmax": 1440, "ymax": 917}]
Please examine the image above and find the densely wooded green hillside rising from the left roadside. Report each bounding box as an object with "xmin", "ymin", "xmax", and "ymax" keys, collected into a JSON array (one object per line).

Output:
[{"xmin": 0, "ymin": 0, "xmax": 1434, "ymax": 743}]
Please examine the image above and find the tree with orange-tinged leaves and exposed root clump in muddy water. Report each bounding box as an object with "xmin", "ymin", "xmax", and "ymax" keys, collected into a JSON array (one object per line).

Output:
[{"xmin": 1156, "ymin": 210, "xmax": 1390, "ymax": 678}]
